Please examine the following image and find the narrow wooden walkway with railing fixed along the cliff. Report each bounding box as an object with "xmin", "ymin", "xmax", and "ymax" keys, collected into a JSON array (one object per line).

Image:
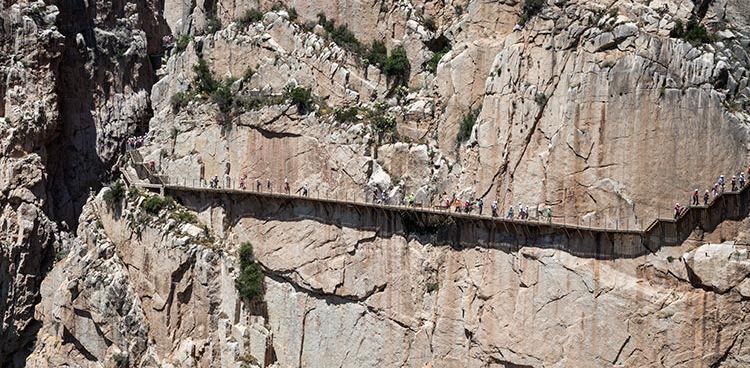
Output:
[{"xmin": 121, "ymin": 151, "xmax": 750, "ymax": 256}]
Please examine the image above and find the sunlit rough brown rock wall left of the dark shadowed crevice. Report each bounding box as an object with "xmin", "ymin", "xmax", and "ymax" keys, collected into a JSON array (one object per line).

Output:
[{"xmin": 0, "ymin": 3, "xmax": 62, "ymax": 366}]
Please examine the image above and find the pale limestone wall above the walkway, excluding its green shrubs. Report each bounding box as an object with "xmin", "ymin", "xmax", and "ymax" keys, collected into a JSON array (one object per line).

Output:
[{"xmin": 144, "ymin": 1, "xmax": 750, "ymax": 228}]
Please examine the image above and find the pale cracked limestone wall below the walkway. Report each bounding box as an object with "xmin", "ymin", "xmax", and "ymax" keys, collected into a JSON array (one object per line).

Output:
[{"xmin": 29, "ymin": 194, "xmax": 750, "ymax": 367}]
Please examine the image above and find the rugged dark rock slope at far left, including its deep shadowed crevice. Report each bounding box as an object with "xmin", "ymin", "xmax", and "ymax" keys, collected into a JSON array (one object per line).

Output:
[{"xmin": 0, "ymin": 1, "xmax": 167, "ymax": 366}]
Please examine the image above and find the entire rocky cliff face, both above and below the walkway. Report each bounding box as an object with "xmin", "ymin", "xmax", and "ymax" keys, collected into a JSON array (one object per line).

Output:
[{"xmin": 0, "ymin": 0, "xmax": 750, "ymax": 367}]
